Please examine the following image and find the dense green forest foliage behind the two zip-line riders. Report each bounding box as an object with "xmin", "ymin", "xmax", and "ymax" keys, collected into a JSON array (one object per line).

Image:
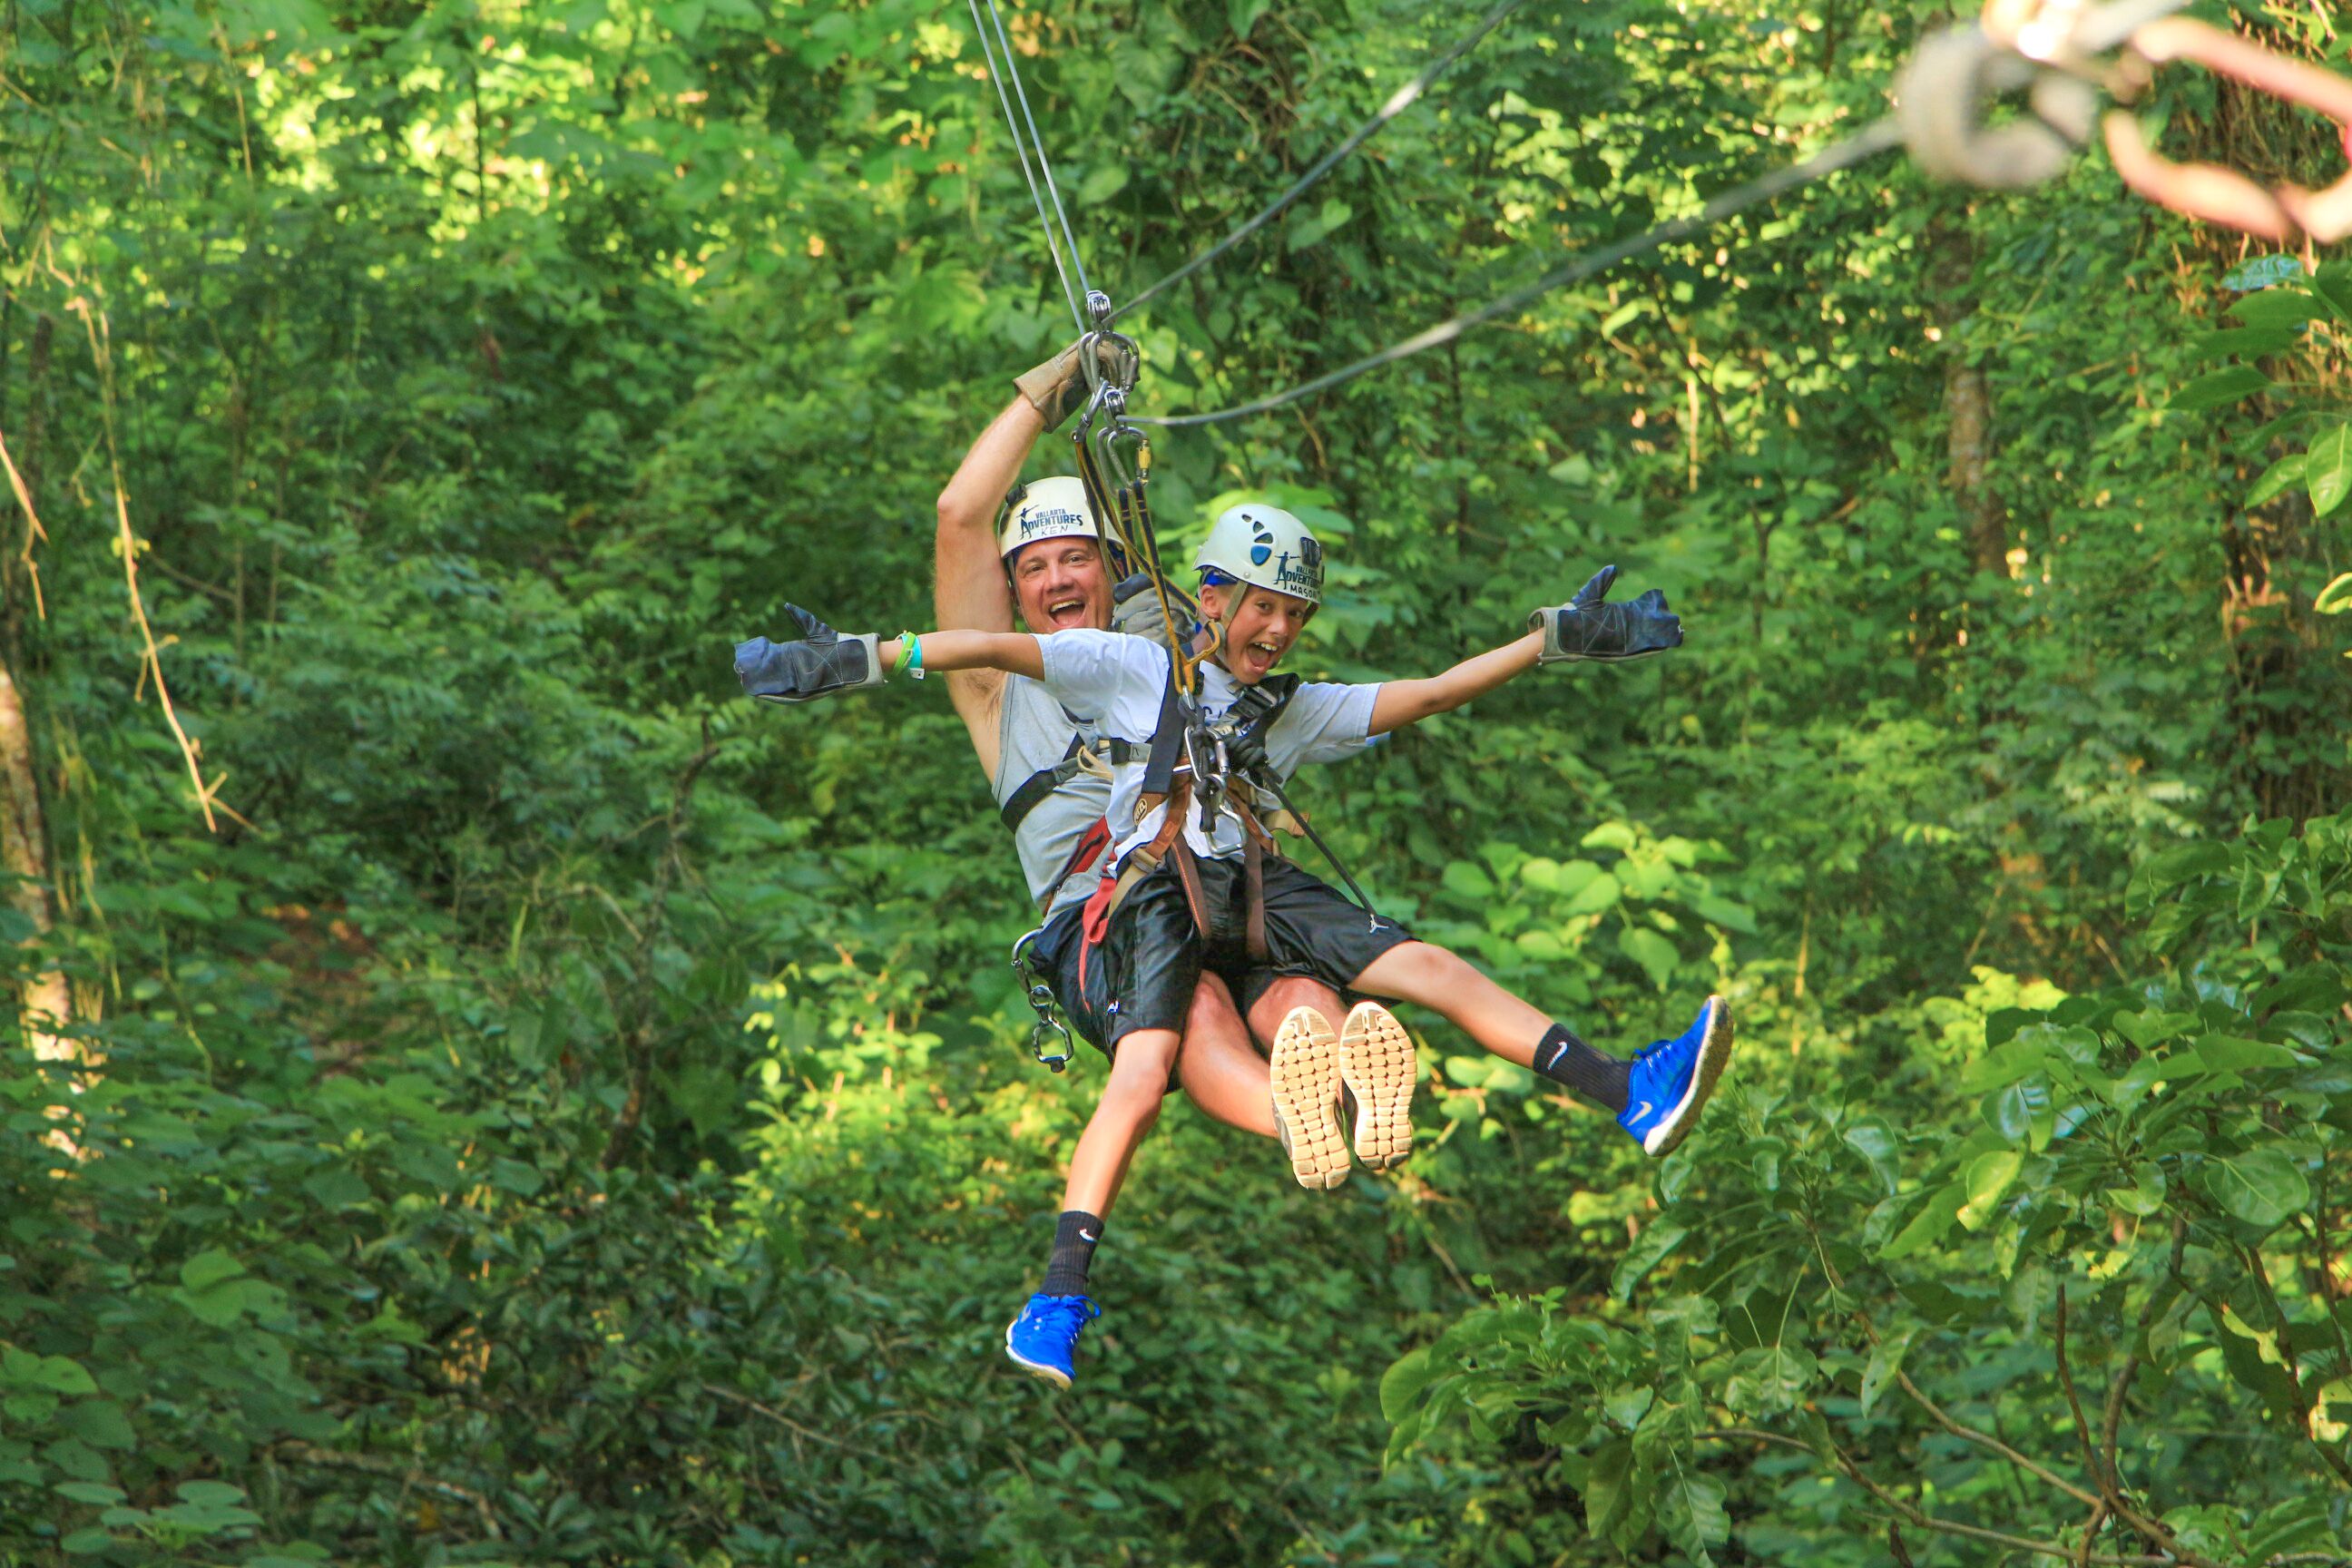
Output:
[{"xmin": 0, "ymin": 0, "xmax": 2352, "ymax": 1568}]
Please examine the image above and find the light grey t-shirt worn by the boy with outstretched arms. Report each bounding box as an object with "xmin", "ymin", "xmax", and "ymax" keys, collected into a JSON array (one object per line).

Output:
[{"xmin": 1037, "ymin": 630, "xmax": 1381, "ymax": 860}]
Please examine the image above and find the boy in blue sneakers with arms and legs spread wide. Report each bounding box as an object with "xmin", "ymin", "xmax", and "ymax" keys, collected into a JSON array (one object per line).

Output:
[{"xmin": 739, "ymin": 491, "xmax": 1731, "ymax": 1385}]
